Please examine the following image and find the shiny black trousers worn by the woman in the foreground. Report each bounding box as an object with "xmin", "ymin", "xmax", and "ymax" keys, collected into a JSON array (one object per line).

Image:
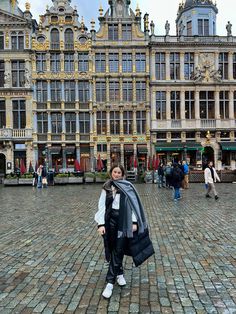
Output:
[{"xmin": 106, "ymin": 209, "xmax": 126, "ymax": 284}]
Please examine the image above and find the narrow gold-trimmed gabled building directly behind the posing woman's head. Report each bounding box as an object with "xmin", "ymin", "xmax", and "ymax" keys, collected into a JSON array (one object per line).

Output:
[{"xmin": 92, "ymin": 0, "xmax": 150, "ymax": 169}]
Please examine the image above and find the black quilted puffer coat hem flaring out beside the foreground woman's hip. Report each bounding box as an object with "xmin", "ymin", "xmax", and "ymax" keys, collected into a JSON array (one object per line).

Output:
[{"xmin": 128, "ymin": 228, "xmax": 155, "ymax": 267}]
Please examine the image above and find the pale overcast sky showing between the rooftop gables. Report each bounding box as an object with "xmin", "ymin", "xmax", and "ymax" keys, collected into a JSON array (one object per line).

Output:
[{"xmin": 18, "ymin": 0, "xmax": 236, "ymax": 35}]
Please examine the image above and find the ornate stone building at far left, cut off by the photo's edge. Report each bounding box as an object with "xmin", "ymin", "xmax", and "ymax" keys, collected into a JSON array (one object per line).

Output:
[{"xmin": 0, "ymin": 0, "xmax": 37, "ymax": 175}]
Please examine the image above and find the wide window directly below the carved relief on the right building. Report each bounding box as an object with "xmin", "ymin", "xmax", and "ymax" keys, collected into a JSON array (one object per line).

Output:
[{"xmin": 200, "ymin": 91, "xmax": 215, "ymax": 119}]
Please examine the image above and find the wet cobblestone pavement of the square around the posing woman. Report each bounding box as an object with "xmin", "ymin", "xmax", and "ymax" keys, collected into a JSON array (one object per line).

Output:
[{"xmin": 0, "ymin": 184, "xmax": 236, "ymax": 314}]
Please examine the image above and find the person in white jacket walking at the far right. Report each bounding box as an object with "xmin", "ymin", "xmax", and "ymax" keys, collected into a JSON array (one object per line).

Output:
[{"xmin": 204, "ymin": 161, "xmax": 220, "ymax": 200}]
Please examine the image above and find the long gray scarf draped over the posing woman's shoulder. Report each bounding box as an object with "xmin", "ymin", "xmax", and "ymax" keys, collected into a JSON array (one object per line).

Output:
[{"xmin": 112, "ymin": 180, "xmax": 147, "ymax": 238}]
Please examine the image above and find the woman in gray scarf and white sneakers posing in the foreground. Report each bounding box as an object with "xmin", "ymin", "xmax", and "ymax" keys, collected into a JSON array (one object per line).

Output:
[{"xmin": 95, "ymin": 165, "xmax": 154, "ymax": 298}]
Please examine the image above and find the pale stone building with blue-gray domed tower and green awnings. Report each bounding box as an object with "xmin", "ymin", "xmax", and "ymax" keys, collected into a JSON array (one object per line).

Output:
[{"xmin": 150, "ymin": 0, "xmax": 236, "ymax": 169}]
